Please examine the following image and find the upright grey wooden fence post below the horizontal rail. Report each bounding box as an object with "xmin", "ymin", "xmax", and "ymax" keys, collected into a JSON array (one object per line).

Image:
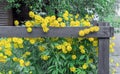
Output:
[{"xmin": 98, "ymin": 38, "xmax": 109, "ymax": 74}]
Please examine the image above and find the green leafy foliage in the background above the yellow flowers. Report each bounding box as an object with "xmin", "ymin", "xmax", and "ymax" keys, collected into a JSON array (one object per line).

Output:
[{"xmin": 1, "ymin": 0, "xmax": 116, "ymax": 19}]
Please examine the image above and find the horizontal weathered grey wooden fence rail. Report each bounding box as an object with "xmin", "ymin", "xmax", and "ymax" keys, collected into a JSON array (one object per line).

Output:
[{"xmin": 0, "ymin": 26, "xmax": 113, "ymax": 38}]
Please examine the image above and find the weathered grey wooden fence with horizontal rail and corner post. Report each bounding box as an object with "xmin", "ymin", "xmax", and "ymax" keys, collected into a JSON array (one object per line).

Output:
[{"xmin": 0, "ymin": 22, "xmax": 114, "ymax": 74}]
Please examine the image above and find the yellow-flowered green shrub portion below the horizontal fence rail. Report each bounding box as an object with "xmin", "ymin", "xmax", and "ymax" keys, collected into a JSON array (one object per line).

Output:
[{"xmin": 0, "ymin": 37, "xmax": 98, "ymax": 74}]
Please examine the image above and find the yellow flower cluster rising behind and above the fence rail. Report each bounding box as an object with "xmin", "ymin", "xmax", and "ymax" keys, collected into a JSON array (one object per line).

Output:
[{"xmin": 14, "ymin": 11, "xmax": 96, "ymax": 32}]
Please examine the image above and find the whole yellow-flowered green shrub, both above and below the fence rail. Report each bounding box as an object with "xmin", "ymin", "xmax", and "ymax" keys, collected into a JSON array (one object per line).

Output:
[{"xmin": 0, "ymin": 11, "xmax": 99, "ymax": 74}]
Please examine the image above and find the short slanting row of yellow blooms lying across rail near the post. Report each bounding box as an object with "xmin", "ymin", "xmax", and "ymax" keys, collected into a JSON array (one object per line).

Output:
[{"xmin": 79, "ymin": 26, "xmax": 100, "ymax": 36}]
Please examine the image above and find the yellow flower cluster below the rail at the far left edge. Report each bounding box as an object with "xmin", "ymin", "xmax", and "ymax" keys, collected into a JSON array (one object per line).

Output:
[{"xmin": 0, "ymin": 37, "xmax": 31, "ymax": 67}]
